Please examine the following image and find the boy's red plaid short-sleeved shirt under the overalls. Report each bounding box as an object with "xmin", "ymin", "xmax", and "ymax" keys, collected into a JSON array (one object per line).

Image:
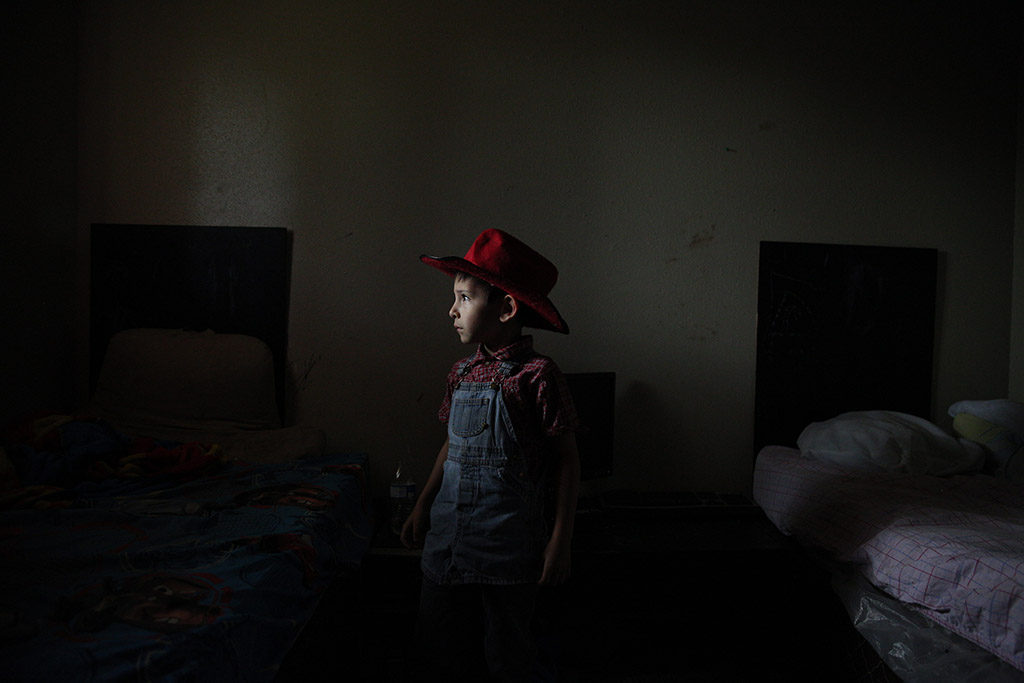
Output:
[{"xmin": 437, "ymin": 336, "xmax": 580, "ymax": 476}]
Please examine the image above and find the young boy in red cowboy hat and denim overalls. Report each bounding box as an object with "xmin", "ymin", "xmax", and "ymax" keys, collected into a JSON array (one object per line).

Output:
[{"xmin": 401, "ymin": 229, "xmax": 580, "ymax": 681}]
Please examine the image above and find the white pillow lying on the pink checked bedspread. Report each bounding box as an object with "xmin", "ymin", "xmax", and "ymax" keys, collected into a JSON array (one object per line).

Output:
[{"xmin": 797, "ymin": 411, "xmax": 985, "ymax": 476}]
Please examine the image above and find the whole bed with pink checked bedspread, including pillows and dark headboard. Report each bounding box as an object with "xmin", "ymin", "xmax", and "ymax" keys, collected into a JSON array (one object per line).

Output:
[{"xmin": 752, "ymin": 242, "xmax": 1024, "ymax": 682}]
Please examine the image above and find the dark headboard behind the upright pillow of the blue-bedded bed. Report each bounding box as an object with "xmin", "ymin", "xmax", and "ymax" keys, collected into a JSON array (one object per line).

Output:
[{"xmin": 89, "ymin": 223, "xmax": 292, "ymax": 414}]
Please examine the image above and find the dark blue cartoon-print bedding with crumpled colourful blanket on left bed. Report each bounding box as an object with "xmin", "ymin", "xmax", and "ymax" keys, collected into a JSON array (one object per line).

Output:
[{"xmin": 0, "ymin": 420, "xmax": 371, "ymax": 681}]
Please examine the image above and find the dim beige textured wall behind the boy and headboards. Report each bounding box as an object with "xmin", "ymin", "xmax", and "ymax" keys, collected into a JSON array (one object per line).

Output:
[{"xmin": 70, "ymin": 0, "xmax": 1019, "ymax": 492}]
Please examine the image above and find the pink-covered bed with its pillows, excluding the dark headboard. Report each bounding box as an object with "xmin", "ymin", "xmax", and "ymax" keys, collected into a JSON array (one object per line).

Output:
[{"xmin": 754, "ymin": 399, "xmax": 1024, "ymax": 681}]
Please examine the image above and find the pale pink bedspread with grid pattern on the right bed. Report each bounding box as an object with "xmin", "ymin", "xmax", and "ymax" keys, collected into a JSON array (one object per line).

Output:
[{"xmin": 754, "ymin": 446, "xmax": 1024, "ymax": 671}]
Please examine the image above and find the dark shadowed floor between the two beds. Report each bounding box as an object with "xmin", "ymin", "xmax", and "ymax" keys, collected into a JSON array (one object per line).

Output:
[{"xmin": 278, "ymin": 499, "xmax": 896, "ymax": 683}]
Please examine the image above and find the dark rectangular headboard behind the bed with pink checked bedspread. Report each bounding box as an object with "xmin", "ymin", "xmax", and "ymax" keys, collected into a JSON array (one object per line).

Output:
[{"xmin": 754, "ymin": 242, "xmax": 938, "ymax": 455}]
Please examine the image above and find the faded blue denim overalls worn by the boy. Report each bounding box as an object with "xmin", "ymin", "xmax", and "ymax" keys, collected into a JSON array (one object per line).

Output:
[{"xmin": 422, "ymin": 360, "xmax": 545, "ymax": 585}]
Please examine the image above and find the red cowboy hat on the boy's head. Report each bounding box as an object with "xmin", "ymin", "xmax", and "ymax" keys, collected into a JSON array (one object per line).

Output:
[{"xmin": 420, "ymin": 228, "xmax": 569, "ymax": 334}]
